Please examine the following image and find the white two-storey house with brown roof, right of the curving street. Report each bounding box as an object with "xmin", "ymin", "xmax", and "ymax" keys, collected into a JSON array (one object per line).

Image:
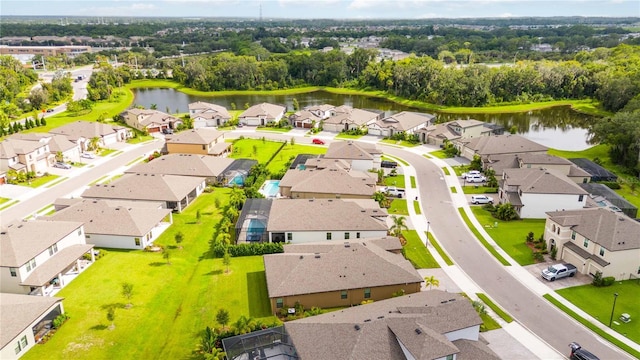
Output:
[{"xmin": 498, "ymin": 168, "xmax": 589, "ymax": 219}]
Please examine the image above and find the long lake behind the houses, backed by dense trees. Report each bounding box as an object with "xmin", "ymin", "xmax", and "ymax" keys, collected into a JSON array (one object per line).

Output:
[{"xmin": 133, "ymin": 88, "xmax": 595, "ymax": 150}]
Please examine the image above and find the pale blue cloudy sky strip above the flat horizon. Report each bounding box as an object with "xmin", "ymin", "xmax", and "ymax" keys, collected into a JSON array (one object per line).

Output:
[{"xmin": 0, "ymin": 0, "xmax": 640, "ymax": 20}]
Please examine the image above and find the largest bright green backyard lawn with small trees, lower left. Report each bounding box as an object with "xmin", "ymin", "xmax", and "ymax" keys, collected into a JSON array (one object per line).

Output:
[{"xmin": 23, "ymin": 189, "xmax": 275, "ymax": 359}]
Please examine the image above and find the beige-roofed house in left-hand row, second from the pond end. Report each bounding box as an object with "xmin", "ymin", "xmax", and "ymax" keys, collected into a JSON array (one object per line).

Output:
[{"xmin": 49, "ymin": 121, "xmax": 131, "ymax": 152}]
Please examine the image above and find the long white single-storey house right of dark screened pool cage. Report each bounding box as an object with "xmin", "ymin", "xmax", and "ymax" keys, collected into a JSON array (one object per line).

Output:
[{"xmin": 267, "ymin": 199, "xmax": 389, "ymax": 244}]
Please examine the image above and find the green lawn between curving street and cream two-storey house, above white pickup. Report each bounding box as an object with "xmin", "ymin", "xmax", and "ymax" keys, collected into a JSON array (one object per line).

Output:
[{"xmin": 471, "ymin": 206, "xmax": 545, "ymax": 266}]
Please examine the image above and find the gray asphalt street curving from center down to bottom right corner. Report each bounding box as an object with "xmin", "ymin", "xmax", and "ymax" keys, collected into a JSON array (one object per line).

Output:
[{"xmin": 384, "ymin": 147, "xmax": 631, "ymax": 360}]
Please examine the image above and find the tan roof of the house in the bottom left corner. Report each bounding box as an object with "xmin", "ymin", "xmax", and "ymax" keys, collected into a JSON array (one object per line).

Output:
[{"xmin": 0, "ymin": 293, "xmax": 63, "ymax": 348}]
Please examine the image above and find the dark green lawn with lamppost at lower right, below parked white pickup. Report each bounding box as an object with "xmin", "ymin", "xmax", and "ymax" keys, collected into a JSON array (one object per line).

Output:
[{"xmin": 556, "ymin": 280, "xmax": 640, "ymax": 343}]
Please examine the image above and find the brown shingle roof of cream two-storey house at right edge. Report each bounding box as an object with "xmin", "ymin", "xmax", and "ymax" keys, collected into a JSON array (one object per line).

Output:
[{"xmin": 547, "ymin": 208, "xmax": 640, "ymax": 251}]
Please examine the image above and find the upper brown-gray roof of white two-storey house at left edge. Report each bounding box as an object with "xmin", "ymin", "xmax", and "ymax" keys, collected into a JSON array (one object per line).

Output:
[{"xmin": 0, "ymin": 220, "xmax": 82, "ymax": 267}]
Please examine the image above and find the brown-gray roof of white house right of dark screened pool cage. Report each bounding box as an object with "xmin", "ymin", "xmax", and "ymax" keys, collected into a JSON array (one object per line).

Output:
[{"xmin": 267, "ymin": 199, "xmax": 388, "ymax": 232}]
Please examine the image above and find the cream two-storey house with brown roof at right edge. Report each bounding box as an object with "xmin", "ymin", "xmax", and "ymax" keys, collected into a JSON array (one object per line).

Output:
[{"xmin": 544, "ymin": 208, "xmax": 640, "ymax": 280}]
